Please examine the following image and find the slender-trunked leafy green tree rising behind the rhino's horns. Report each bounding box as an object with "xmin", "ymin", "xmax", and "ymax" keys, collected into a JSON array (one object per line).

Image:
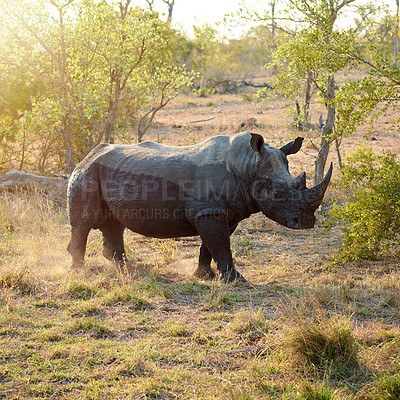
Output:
[{"xmin": 260, "ymin": 0, "xmax": 355, "ymax": 184}]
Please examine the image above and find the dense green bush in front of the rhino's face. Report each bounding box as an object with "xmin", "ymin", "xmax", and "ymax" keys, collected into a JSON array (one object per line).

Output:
[{"xmin": 328, "ymin": 147, "xmax": 400, "ymax": 262}]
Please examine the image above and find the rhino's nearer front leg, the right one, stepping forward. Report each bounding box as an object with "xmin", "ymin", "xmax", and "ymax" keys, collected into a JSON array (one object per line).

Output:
[{"xmin": 195, "ymin": 216, "xmax": 244, "ymax": 283}]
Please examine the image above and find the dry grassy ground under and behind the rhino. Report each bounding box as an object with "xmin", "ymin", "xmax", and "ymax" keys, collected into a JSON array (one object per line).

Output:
[{"xmin": 0, "ymin": 86, "xmax": 400, "ymax": 400}]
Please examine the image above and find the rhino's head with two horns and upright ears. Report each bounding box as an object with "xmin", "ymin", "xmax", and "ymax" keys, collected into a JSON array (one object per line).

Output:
[{"xmin": 250, "ymin": 133, "xmax": 332, "ymax": 229}]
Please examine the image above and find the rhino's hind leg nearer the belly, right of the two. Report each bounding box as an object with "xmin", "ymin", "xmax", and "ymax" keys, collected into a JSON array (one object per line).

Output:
[{"xmin": 99, "ymin": 219, "xmax": 125, "ymax": 264}]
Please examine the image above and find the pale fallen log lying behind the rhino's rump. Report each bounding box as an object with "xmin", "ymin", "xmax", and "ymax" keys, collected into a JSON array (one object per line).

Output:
[{"xmin": 0, "ymin": 169, "xmax": 68, "ymax": 198}]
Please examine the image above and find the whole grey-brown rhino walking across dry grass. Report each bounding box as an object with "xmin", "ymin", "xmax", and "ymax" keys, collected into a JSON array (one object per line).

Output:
[{"xmin": 68, "ymin": 132, "xmax": 332, "ymax": 282}]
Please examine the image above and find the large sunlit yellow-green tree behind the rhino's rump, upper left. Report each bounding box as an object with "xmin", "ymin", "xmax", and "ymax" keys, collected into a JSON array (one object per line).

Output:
[{"xmin": 0, "ymin": 0, "xmax": 191, "ymax": 171}]
